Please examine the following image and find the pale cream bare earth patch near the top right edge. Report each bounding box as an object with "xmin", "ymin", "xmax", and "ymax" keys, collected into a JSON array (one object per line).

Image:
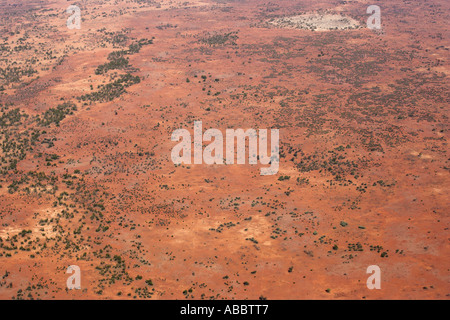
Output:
[{"xmin": 270, "ymin": 13, "xmax": 360, "ymax": 31}]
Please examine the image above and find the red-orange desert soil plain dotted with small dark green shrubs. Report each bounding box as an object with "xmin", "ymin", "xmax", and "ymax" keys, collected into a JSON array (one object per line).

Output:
[{"xmin": 0, "ymin": 0, "xmax": 450, "ymax": 299}]
